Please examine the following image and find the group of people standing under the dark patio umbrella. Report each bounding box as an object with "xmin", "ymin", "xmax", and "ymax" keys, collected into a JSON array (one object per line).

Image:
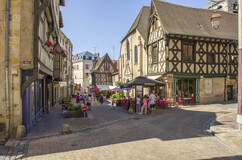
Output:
[{"xmin": 136, "ymin": 91, "xmax": 158, "ymax": 115}]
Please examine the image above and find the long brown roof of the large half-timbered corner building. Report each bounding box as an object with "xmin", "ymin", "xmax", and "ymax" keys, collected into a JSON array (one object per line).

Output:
[{"xmin": 153, "ymin": 0, "xmax": 238, "ymax": 40}]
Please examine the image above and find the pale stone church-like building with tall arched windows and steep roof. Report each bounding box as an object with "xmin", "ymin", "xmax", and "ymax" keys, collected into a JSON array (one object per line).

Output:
[{"xmin": 119, "ymin": 7, "xmax": 150, "ymax": 82}]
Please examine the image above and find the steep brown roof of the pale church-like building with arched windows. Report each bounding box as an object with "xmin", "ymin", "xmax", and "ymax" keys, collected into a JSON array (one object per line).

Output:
[{"xmin": 122, "ymin": 6, "xmax": 150, "ymax": 42}]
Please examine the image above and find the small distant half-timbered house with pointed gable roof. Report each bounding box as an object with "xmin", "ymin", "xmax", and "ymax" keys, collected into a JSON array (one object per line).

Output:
[{"xmin": 89, "ymin": 53, "xmax": 117, "ymax": 88}]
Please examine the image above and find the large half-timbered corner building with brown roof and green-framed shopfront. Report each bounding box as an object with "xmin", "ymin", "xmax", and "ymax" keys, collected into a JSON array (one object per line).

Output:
[{"xmin": 147, "ymin": 0, "xmax": 238, "ymax": 103}]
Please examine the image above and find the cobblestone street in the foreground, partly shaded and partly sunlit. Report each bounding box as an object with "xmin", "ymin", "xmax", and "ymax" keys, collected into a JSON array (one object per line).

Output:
[{"xmin": 14, "ymin": 104, "xmax": 242, "ymax": 160}]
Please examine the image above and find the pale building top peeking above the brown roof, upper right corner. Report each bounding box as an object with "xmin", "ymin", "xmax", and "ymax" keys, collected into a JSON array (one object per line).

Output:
[{"xmin": 205, "ymin": 0, "xmax": 238, "ymax": 13}]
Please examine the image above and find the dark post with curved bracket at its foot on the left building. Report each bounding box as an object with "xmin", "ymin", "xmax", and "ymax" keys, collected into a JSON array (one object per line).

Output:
[{"xmin": 21, "ymin": 0, "xmax": 49, "ymax": 97}]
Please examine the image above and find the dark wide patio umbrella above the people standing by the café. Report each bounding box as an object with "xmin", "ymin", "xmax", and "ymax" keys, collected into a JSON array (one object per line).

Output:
[{"xmin": 120, "ymin": 76, "xmax": 165, "ymax": 88}]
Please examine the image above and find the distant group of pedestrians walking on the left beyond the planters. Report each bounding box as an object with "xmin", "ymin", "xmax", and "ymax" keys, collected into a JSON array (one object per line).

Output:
[{"xmin": 76, "ymin": 93, "xmax": 104, "ymax": 110}]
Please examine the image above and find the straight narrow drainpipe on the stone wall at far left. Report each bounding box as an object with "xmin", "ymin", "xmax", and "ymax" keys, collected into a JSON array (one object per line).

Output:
[{"xmin": 5, "ymin": 0, "xmax": 10, "ymax": 138}]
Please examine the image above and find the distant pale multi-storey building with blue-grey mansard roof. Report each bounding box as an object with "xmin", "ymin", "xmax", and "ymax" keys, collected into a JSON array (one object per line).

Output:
[{"xmin": 72, "ymin": 51, "xmax": 99, "ymax": 92}]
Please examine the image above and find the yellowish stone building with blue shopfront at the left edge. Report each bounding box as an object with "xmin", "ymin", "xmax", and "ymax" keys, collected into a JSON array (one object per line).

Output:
[{"xmin": 0, "ymin": 0, "xmax": 65, "ymax": 138}]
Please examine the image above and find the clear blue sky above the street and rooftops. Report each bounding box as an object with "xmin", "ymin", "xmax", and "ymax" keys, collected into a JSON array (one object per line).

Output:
[{"xmin": 61, "ymin": 0, "xmax": 206, "ymax": 59}]
